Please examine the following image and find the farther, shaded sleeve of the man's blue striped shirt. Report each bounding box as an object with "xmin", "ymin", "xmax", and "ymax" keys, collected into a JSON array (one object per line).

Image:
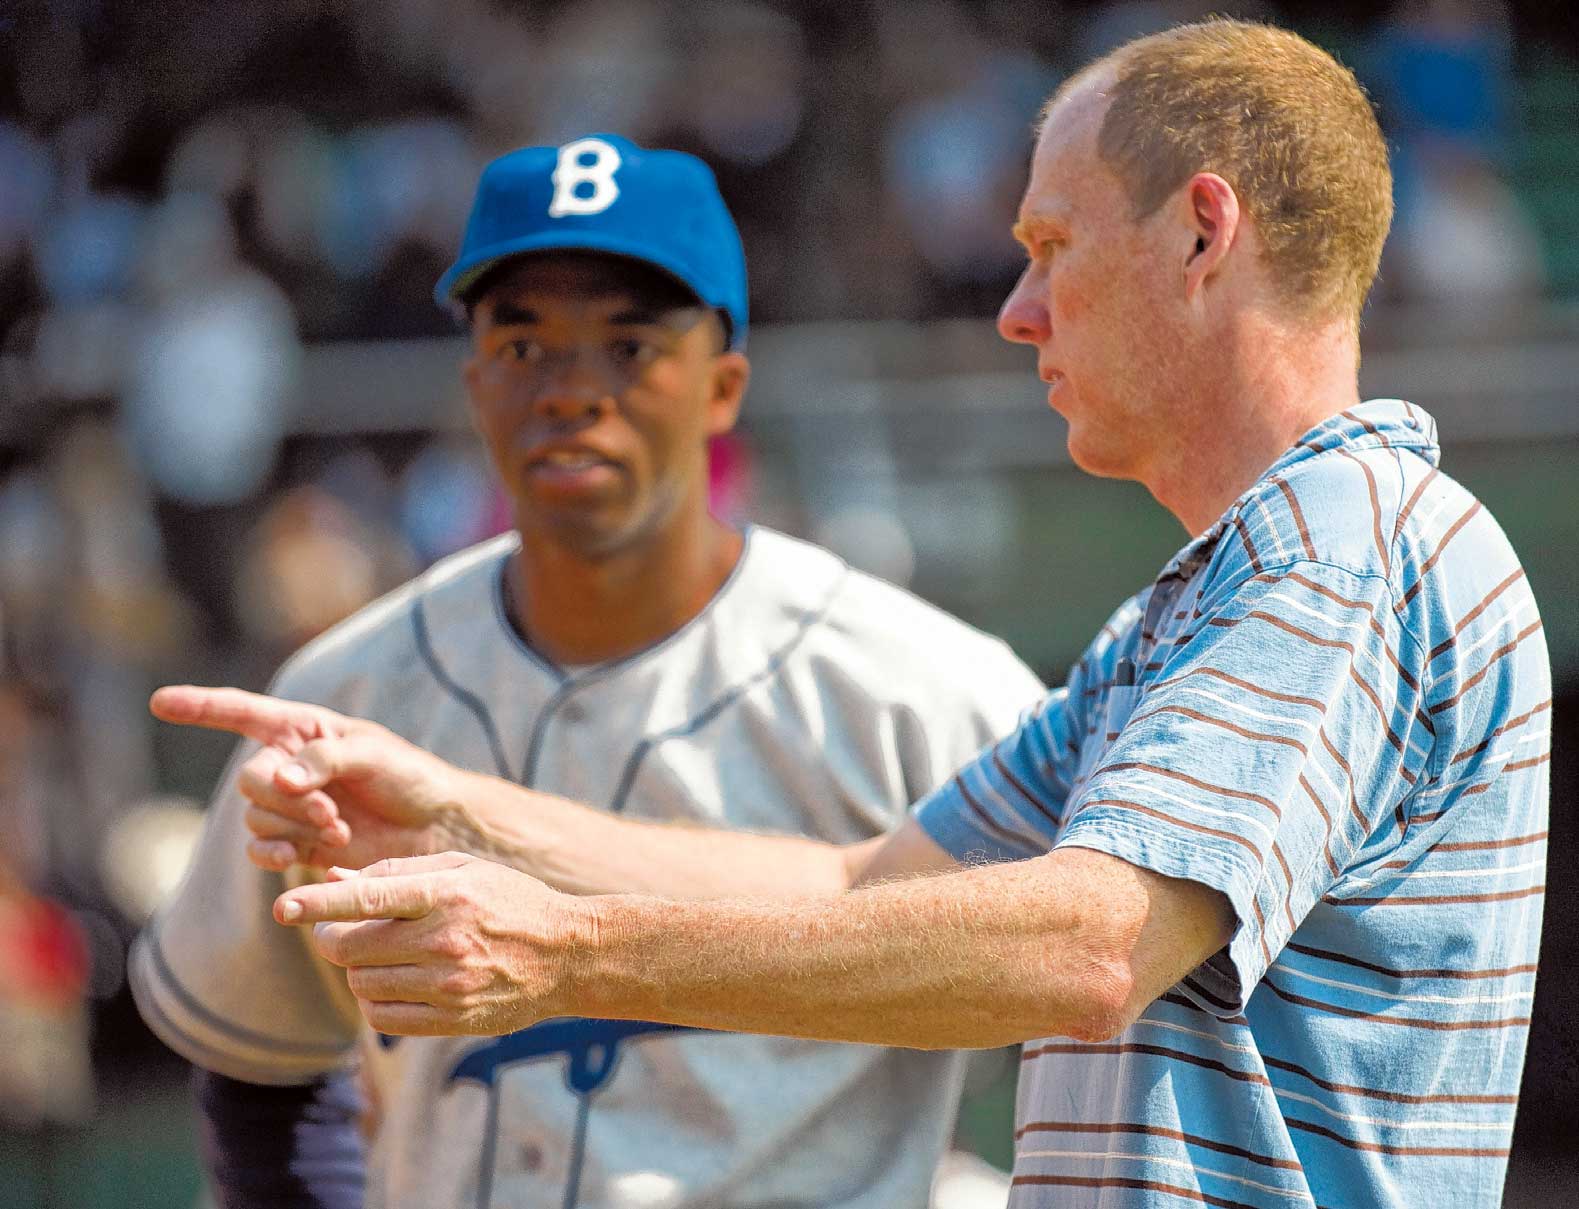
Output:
[{"xmin": 916, "ymin": 625, "xmax": 1115, "ymax": 862}]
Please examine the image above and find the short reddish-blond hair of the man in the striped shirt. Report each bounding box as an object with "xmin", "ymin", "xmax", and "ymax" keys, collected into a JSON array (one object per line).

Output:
[{"xmin": 1048, "ymin": 17, "xmax": 1393, "ymax": 320}]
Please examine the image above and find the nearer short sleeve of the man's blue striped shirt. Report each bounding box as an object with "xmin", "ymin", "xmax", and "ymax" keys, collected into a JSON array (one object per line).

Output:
[{"xmin": 1060, "ymin": 563, "xmax": 1431, "ymax": 1015}]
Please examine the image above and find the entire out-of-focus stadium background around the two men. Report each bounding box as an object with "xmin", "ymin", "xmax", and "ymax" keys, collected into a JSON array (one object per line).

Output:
[{"xmin": 0, "ymin": 0, "xmax": 1579, "ymax": 1209}]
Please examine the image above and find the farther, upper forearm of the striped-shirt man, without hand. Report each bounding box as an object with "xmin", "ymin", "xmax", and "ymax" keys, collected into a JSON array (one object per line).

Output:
[{"xmin": 448, "ymin": 775, "xmax": 881, "ymax": 900}]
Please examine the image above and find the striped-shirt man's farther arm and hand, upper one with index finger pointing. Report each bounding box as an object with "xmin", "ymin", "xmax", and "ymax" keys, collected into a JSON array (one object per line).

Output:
[{"xmin": 152, "ymin": 685, "xmax": 954, "ymax": 898}]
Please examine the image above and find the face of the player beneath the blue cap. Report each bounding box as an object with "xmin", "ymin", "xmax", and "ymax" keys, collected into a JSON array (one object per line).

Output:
[{"xmin": 464, "ymin": 253, "xmax": 748, "ymax": 557}]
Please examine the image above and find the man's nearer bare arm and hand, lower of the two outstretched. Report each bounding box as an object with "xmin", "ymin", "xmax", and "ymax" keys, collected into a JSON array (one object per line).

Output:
[{"xmin": 276, "ymin": 849, "xmax": 1232, "ymax": 1048}]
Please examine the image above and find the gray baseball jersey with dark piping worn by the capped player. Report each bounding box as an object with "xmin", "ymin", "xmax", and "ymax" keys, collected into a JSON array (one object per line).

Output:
[{"xmin": 133, "ymin": 527, "xmax": 1042, "ymax": 1209}]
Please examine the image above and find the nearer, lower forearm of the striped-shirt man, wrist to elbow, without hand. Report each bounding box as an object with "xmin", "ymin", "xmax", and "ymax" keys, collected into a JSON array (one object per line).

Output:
[{"xmin": 568, "ymin": 852, "xmax": 1145, "ymax": 1048}]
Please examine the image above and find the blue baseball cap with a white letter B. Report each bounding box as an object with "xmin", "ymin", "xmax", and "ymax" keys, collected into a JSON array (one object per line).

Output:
[{"xmin": 433, "ymin": 134, "xmax": 747, "ymax": 349}]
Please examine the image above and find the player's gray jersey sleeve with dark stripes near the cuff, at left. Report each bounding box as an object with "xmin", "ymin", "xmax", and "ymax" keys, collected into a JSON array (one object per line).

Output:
[{"xmin": 129, "ymin": 672, "xmax": 362, "ymax": 1084}]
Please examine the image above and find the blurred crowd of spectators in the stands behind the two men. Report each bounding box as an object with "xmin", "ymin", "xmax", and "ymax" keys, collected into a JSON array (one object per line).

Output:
[{"xmin": 0, "ymin": 0, "xmax": 1557, "ymax": 1155}]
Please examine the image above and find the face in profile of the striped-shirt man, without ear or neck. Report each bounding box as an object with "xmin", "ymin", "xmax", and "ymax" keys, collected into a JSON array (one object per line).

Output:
[{"xmin": 998, "ymin": 79, "xmax": 1186, "ymax": 481}]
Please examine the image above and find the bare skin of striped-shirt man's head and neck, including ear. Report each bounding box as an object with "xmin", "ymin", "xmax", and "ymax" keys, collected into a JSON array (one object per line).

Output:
[{"xmin": 998, "ymin": 73, "xmax": 1358, "ymax": 533}]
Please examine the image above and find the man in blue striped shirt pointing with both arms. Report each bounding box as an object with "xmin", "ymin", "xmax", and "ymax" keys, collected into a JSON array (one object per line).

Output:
[{"xmin": 181, "ymin": 21, "xmax": 1551, "ymax": 1209}]
